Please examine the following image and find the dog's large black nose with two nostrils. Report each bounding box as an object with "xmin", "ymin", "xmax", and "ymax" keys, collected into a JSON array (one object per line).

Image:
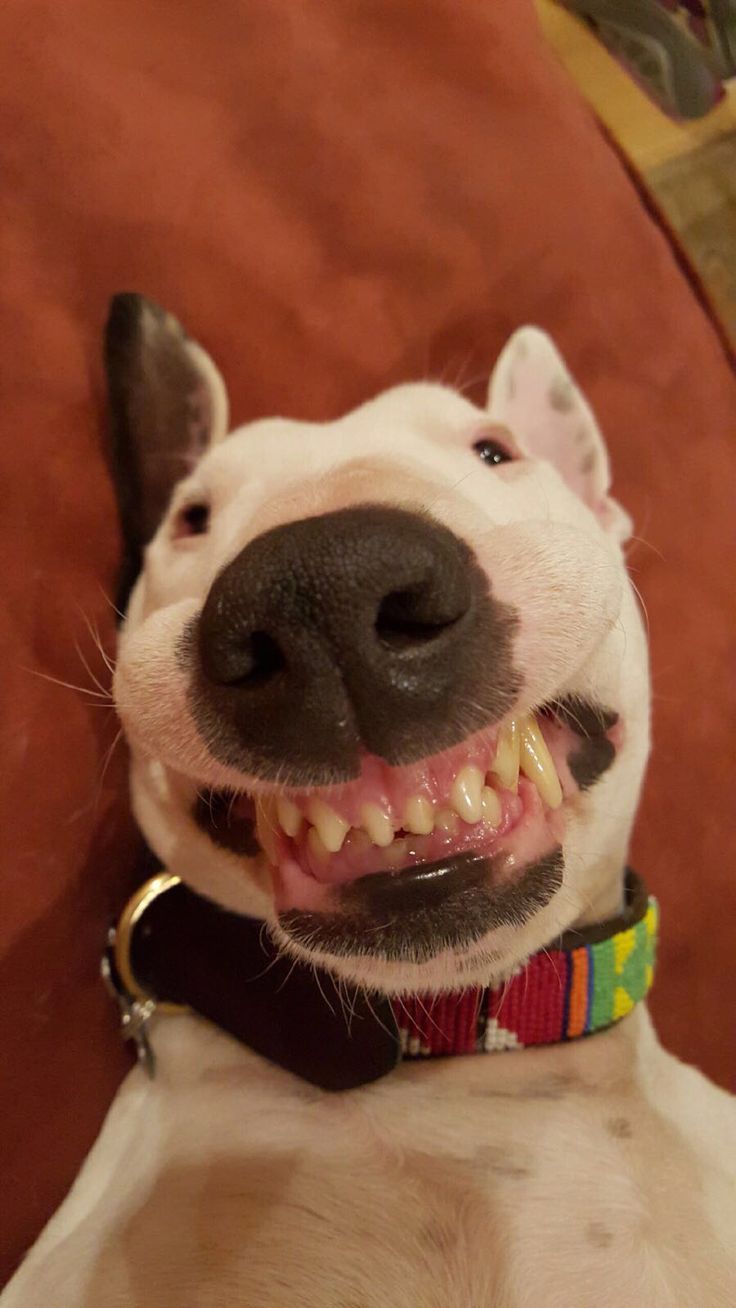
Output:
[{"xmin": 191, "ymin": 505, "xmax": 516, "ymax": 785}]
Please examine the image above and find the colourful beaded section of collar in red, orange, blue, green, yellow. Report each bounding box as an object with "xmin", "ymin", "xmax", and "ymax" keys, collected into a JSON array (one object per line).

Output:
[{"xmin": 393, "ymin": 896, "xmax": 659, "ymax": 1058}]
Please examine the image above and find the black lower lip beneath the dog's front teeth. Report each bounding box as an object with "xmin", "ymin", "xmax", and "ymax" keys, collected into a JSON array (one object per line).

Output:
[{"xmin": 278, "ymin": 846, "xmax": 565, "ymax": 963}]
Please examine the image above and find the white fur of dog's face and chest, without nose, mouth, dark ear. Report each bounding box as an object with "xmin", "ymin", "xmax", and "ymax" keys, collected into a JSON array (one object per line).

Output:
[{"xmin": 1, "ymin": 330, "xmax": 736, "ymax": 1308}]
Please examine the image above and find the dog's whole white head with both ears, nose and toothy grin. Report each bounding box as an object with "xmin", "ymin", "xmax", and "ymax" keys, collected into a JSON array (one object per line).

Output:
[{"xmin": 107, "ymin": 296, "xmax": 648, "ymax": 991}]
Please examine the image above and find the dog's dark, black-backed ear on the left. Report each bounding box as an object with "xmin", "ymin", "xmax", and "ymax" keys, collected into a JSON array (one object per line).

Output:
[{"xmin": 105, "ymin": 294, "xmax": 227, "ymax": 608}]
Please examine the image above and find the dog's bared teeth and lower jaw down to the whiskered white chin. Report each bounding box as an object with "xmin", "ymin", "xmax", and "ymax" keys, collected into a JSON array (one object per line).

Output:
[{"xmin": 162, "ymin": 702, "xmax": 621, "ymax": 993}]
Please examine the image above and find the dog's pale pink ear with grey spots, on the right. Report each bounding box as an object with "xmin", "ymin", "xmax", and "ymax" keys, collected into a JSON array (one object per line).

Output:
[{"xmin": 488, "ymin": 327, "xmax": 631, "ymax": 542}]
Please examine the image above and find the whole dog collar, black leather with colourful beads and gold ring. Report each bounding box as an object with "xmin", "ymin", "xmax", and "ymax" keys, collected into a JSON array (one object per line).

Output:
[{"xmin": 102, "ymin": 870, "xmax": 658, "ymax": 1090}]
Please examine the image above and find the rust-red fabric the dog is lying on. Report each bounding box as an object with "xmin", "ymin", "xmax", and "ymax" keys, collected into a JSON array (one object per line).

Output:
[{"xmin": 0, "ymin": 0, "xmax": 736, "ymax": 1267}]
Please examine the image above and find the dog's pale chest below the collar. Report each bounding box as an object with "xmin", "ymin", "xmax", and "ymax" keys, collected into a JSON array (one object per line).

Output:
[{"xmin": 21, "ymin": 1019, "xmax": 736, "ymax": 1308}]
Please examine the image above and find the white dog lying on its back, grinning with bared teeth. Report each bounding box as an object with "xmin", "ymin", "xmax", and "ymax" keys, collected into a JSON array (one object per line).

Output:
[{"xmin": 3, "ymin": 296, "xmax": 736, "ymax": 1308}]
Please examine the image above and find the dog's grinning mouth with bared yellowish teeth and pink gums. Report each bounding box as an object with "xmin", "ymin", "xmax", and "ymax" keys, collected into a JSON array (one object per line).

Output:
[{"xmin": 195, "ymin": 698, "xmax": 621, "ymax": 938}]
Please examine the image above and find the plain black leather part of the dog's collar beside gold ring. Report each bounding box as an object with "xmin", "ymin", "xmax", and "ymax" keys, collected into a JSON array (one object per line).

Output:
[{"xmin": 114, "ymin": 874, "xmax": 401, "ymax": 1090}]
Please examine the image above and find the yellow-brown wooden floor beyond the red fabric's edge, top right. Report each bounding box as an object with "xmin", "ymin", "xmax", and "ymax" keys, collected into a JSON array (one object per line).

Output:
[{"xmin": 536, "ymin": 0, "xmax": 736, "ymax": 347}]
